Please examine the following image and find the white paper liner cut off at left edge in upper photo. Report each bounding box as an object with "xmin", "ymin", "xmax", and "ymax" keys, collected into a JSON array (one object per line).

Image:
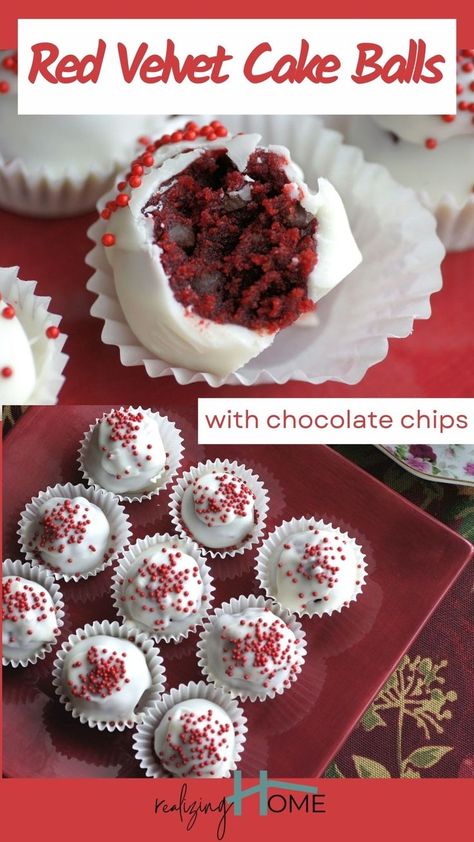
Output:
[{"xmin": 0, "ymin": 266, "xmax": 69, "ymax": 406}]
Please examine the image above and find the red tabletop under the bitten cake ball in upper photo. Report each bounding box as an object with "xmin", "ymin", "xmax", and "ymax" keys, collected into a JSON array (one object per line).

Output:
[{"xmin": 0, "ymin": 206, "xmax": 474, "ymax": 404}]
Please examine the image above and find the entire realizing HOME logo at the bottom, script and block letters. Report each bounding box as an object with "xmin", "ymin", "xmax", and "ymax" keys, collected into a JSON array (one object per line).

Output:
[{"xmin": 154, "ymin": 771, "xmax": 326, "ymax": 840}]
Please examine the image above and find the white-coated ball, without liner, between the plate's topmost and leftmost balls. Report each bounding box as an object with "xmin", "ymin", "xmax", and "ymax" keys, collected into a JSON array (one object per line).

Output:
[{"xmin": 28, "ymin": 497, "xmax": 112, "ymax": 575}]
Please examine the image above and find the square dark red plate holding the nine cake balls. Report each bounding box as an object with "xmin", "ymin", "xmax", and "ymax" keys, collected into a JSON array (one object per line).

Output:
[{"xmin": 4, "ymin": 404, "xmax": 473, "ymax": 778}]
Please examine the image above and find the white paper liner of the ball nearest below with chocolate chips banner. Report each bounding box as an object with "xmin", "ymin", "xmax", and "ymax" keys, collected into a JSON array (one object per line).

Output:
[{"xmin": 169, "ymin": 459, "xmax": 268, "ymax": 558}]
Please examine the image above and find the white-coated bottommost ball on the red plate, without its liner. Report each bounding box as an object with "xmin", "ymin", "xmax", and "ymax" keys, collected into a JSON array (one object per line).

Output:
[{"xmin": 154, "ymin": 699, "xmax": 235, "ymax": 778}]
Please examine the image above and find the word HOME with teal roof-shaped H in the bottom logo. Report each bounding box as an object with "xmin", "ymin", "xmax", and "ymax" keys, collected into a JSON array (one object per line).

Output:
[{"xmin": 226, "ymin": 771, "xmax": 326, "ymax": 816}]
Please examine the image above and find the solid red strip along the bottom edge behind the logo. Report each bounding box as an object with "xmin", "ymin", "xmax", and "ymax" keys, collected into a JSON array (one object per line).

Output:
[{"xmin": 1, "ymin": 778, "xmax": 472, "ymax": 842}]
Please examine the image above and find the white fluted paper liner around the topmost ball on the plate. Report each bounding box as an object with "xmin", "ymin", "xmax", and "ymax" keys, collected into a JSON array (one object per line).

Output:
[{"xmin": 78, "ymin": 406, "xmax": 184, "ymax": 503}]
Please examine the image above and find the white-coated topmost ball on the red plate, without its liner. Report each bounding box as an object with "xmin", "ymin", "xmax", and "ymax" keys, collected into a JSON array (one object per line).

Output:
[{"xmin": 89, "ymin": 407, "xmax": 166, "ymax": 494}]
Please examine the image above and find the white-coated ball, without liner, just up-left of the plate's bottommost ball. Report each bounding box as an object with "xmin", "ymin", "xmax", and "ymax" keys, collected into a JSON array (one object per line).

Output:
[{"xmin": 62, "ymin": 635, "xmax": 151, "ymax": 722}]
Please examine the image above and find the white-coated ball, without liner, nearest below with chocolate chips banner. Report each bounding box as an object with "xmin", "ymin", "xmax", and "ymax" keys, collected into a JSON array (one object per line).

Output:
[{"xmin": 181, "ymin": 471, "xmax": 255, "ymax": 549}]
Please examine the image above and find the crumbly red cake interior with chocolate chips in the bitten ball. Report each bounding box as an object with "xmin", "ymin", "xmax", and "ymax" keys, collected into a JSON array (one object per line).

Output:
[{"xmin": 142, "ymin": 149, "xmax": 317, "ymax": 332}]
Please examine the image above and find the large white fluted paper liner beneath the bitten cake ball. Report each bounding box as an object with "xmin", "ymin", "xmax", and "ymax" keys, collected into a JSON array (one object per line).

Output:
[{"xmin": 86, "ymin": 115, "xmax": 444, "ymax": 386}]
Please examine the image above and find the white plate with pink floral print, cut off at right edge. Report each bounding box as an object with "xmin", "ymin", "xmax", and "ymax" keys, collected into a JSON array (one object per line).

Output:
[{"xmin": 377, "ymin": 444, "xmax": 474, "ymax": 488}]
